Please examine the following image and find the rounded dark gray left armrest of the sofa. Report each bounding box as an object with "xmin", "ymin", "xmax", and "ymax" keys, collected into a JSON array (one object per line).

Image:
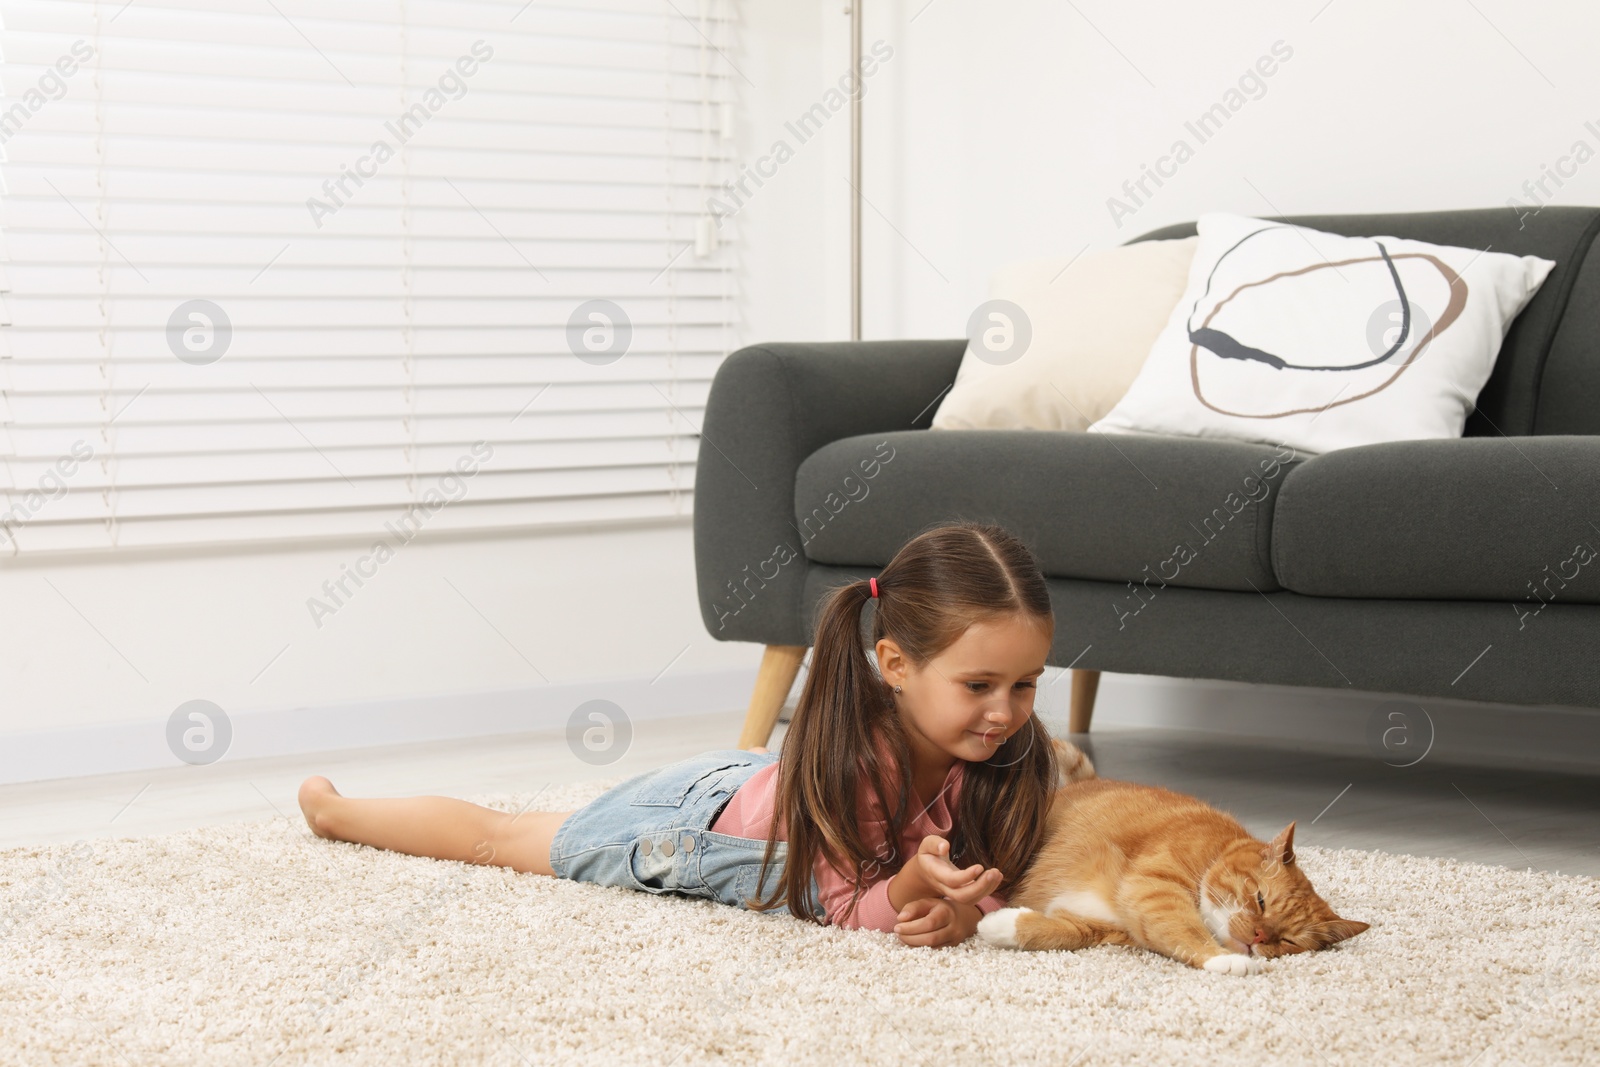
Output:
[{"xmin": 694, "ymin": 339, "xmax": 966, "ymax": 645}]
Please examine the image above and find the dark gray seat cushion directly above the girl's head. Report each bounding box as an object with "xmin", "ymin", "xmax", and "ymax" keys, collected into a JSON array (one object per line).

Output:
[{"xmin": 794, "ymin": 430, "xmax": 1298, "ymax": 592}]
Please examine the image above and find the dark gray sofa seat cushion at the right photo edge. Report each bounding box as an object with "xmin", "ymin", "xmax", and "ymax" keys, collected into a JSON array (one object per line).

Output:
[{"xmin": 1272, "ymin": 435, "xmax": 1600, "ymax": 614}]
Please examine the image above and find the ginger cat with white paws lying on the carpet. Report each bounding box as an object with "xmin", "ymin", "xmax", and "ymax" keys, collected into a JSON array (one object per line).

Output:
[{"xmin": 978, "ymin": 741, "xmax": 1368, "ymax": 974}]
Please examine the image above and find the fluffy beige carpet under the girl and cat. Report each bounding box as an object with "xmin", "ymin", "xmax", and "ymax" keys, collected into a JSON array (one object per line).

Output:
[{"xmin": 0, "ymin": 779, "xmax": 1600, "ymax": 1067}]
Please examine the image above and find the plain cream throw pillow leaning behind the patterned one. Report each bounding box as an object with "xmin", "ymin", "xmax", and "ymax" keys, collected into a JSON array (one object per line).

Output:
[{"xmin": 933, "ymin": 237, "xmax": 1198, "ymax": 430}]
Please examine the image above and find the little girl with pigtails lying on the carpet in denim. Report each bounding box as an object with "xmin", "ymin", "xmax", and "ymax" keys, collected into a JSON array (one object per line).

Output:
[{"xmin": 299, "ymin": 522, "xmax": 1058, "ymax": 945}]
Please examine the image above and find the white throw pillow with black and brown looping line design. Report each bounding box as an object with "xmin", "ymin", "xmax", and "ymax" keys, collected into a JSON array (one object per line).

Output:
[{"xmin": 1090, "ymin": 213, "xmax": 1555, "ymax": 453}]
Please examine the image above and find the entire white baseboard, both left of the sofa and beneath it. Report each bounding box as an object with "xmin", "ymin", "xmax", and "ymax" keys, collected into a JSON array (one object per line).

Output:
[{"xmin": 15, "ymin": 669, "xmax": 1600, "ymax": 784}]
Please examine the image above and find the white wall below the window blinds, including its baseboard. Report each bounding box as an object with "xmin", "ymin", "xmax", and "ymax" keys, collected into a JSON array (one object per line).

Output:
[{"xmin": 0, "ymin": 520, "xmax": 758, "ymax": 782}]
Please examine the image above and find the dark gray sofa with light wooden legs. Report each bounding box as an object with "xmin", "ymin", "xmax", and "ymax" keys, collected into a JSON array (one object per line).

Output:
[{"xmin": 694, "ymin": 206, "xmax": 1600, "ymax": 747}]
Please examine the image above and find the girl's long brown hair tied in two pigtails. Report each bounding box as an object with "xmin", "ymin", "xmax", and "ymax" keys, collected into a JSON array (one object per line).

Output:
[{"xmin": 747, "ymin": 522, "xmax": 1056, "ymax": 925}]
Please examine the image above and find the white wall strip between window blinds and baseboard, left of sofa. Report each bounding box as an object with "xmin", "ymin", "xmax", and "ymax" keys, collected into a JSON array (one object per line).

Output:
[{"xmin": 0, "ymin": 522, "xmax": 729, "ymax": 729}]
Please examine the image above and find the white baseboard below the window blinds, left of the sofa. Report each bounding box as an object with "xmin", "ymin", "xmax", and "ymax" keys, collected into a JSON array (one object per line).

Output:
[{"xmin": 0, "ymin": 669, "xmax": 755, "ymax": 784}]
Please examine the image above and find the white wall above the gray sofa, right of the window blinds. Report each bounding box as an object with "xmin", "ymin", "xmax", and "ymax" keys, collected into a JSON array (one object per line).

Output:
[{"xmin": 744, "ymin": 0, "xmax": 1600, "ymax": 339}]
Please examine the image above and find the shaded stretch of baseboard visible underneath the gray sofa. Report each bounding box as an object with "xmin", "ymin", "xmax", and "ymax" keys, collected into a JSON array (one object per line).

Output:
[{"xmin": 1075, "ymin": 670, "xmax": 1600, "ymax": 773}]
